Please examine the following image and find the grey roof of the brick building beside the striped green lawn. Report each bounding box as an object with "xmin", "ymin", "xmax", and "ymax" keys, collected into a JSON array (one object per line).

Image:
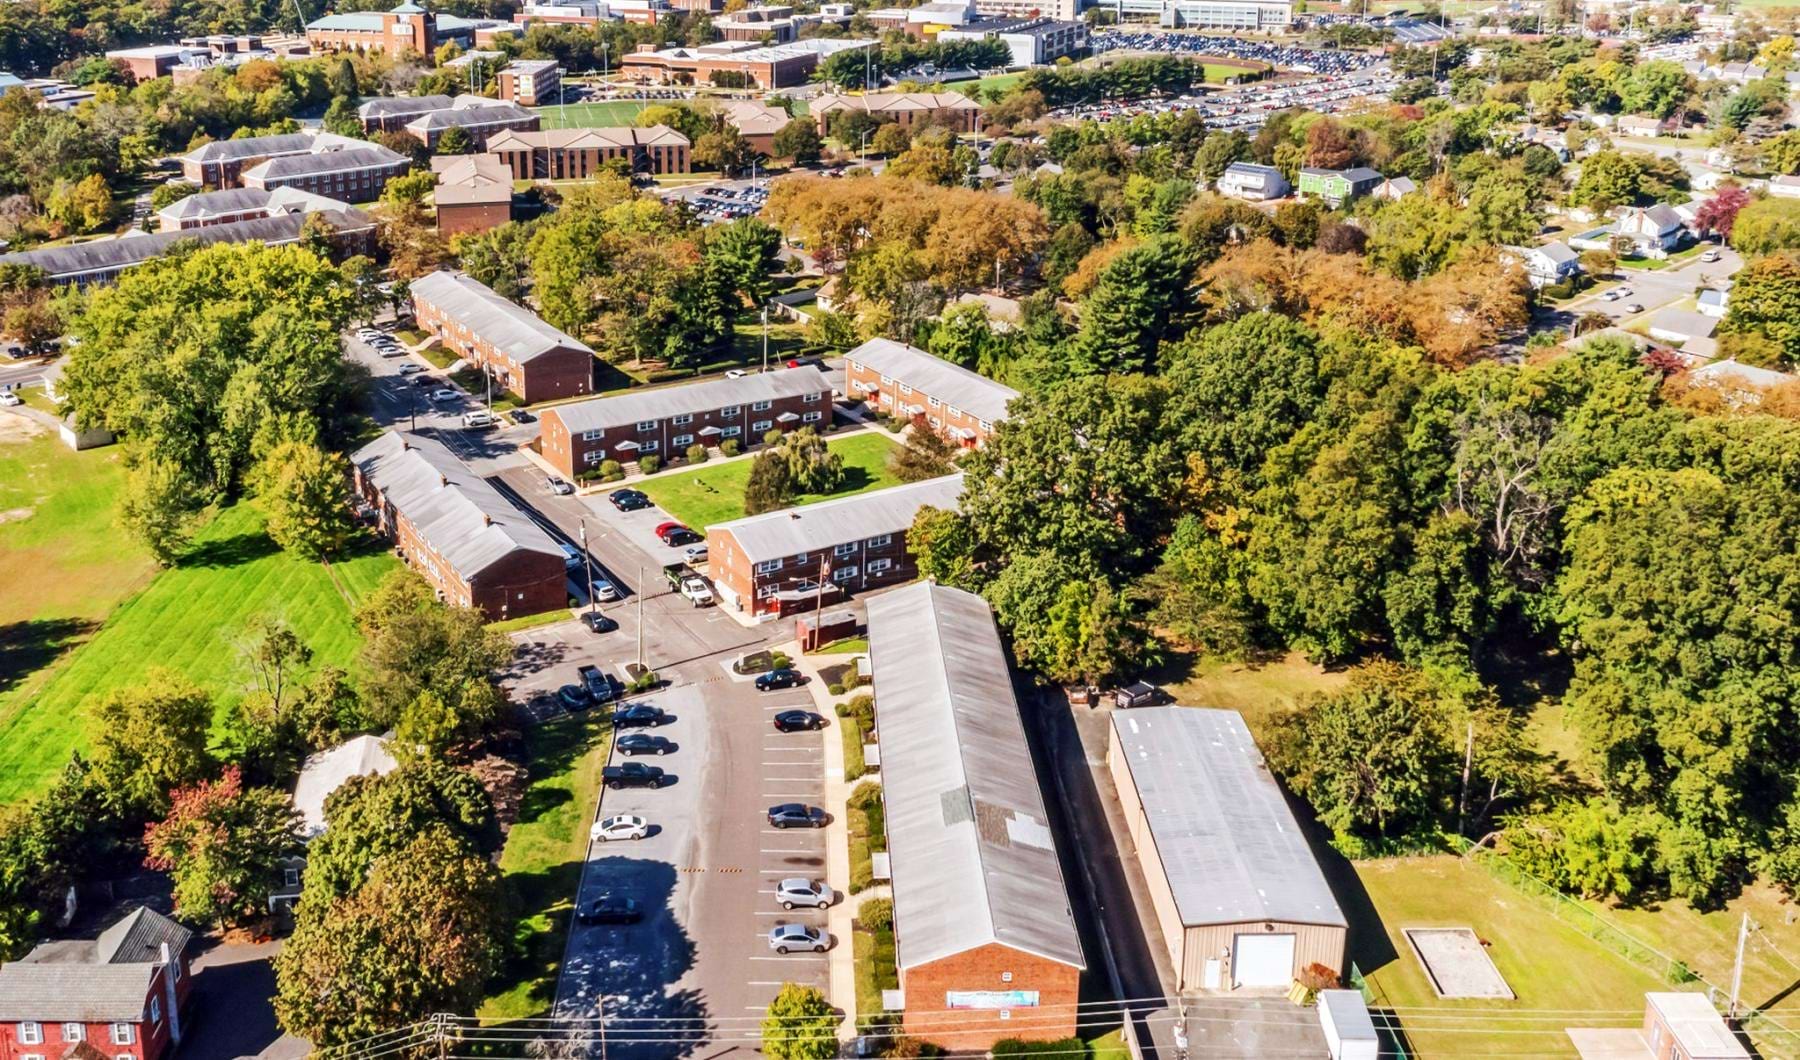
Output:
[{"xmin": 351, "ymin": 432, "xmax": 563, "ymax": 581}]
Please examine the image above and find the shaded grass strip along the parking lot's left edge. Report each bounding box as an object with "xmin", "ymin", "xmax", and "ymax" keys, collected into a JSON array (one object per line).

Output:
[{"xmin": 477, "ymin": 711, "xmax": 612, "ymax": 1020}]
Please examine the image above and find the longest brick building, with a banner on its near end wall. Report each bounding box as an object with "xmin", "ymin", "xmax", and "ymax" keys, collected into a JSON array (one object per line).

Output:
[{"xmin": 868, "ymin": 581, "xmax": 1085, "ymax": 1053}]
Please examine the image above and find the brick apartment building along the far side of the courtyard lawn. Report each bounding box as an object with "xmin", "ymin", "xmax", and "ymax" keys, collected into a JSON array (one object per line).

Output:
[{"xmin": 538, "ymin": 367, "xmax": 832, "ymax": 479}]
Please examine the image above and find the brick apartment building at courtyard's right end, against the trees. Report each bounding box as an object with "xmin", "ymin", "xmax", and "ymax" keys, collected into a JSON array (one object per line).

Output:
[{"xmin": 844, "ymin": 338, "xmax": 1019, "ymax": 446}]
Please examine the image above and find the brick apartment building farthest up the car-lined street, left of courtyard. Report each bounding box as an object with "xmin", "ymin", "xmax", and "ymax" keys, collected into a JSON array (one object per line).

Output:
[{"xmin": 412, "ymin": 272, "xmax": 594, "ymax": 405}]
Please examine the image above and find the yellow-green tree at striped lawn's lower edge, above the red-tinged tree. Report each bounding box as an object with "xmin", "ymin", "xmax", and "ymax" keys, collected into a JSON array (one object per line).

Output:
[{"xmin": 90, "ymin": 666, "xmax": 212, "ymax": 819}]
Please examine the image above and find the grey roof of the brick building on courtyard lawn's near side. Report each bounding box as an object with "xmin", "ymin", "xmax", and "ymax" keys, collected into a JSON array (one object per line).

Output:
[{"xmin": 706, "ymin": 475, "xmax": 963, "ymax": 563}]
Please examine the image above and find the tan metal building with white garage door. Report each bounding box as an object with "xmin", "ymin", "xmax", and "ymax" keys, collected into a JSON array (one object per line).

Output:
[{"xmin": 1107, "ymin": 707, "xmax": 1346, "ymax": 990}]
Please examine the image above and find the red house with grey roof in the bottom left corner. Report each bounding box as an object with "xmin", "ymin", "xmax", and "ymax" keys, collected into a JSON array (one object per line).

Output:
[{"xmin": 0, "ymin": 905, "xmax": 193, "ymax": 1060}]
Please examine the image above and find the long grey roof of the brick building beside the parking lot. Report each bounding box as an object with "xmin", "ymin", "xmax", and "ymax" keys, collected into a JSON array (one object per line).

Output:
[{"xmin": 868, "ymin": 581, "xmax": 1085, "ymax": 970}]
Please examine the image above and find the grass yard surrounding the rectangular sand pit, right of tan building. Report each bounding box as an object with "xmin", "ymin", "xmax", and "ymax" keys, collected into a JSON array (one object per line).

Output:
[{"xmin": 1334, "ymin": 855, "xmax": 1672, "ymax": 1056}]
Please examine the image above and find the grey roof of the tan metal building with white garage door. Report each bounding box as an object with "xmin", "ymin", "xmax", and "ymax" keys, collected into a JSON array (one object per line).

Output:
[{"xmin": 1112, "ymin": 707, "xmax": 1346, "ymax": 927}]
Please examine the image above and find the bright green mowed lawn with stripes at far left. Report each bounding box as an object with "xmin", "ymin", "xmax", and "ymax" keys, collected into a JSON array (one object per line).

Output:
[{"xmin": 0, "ymin": 503, "xmax": 396, "ymax": 804}]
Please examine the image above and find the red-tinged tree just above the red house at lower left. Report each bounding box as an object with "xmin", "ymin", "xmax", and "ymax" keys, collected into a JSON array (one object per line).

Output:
[{"xmin": 144, "ymin": 768, "xmax": 302, "ymax": 927}]
